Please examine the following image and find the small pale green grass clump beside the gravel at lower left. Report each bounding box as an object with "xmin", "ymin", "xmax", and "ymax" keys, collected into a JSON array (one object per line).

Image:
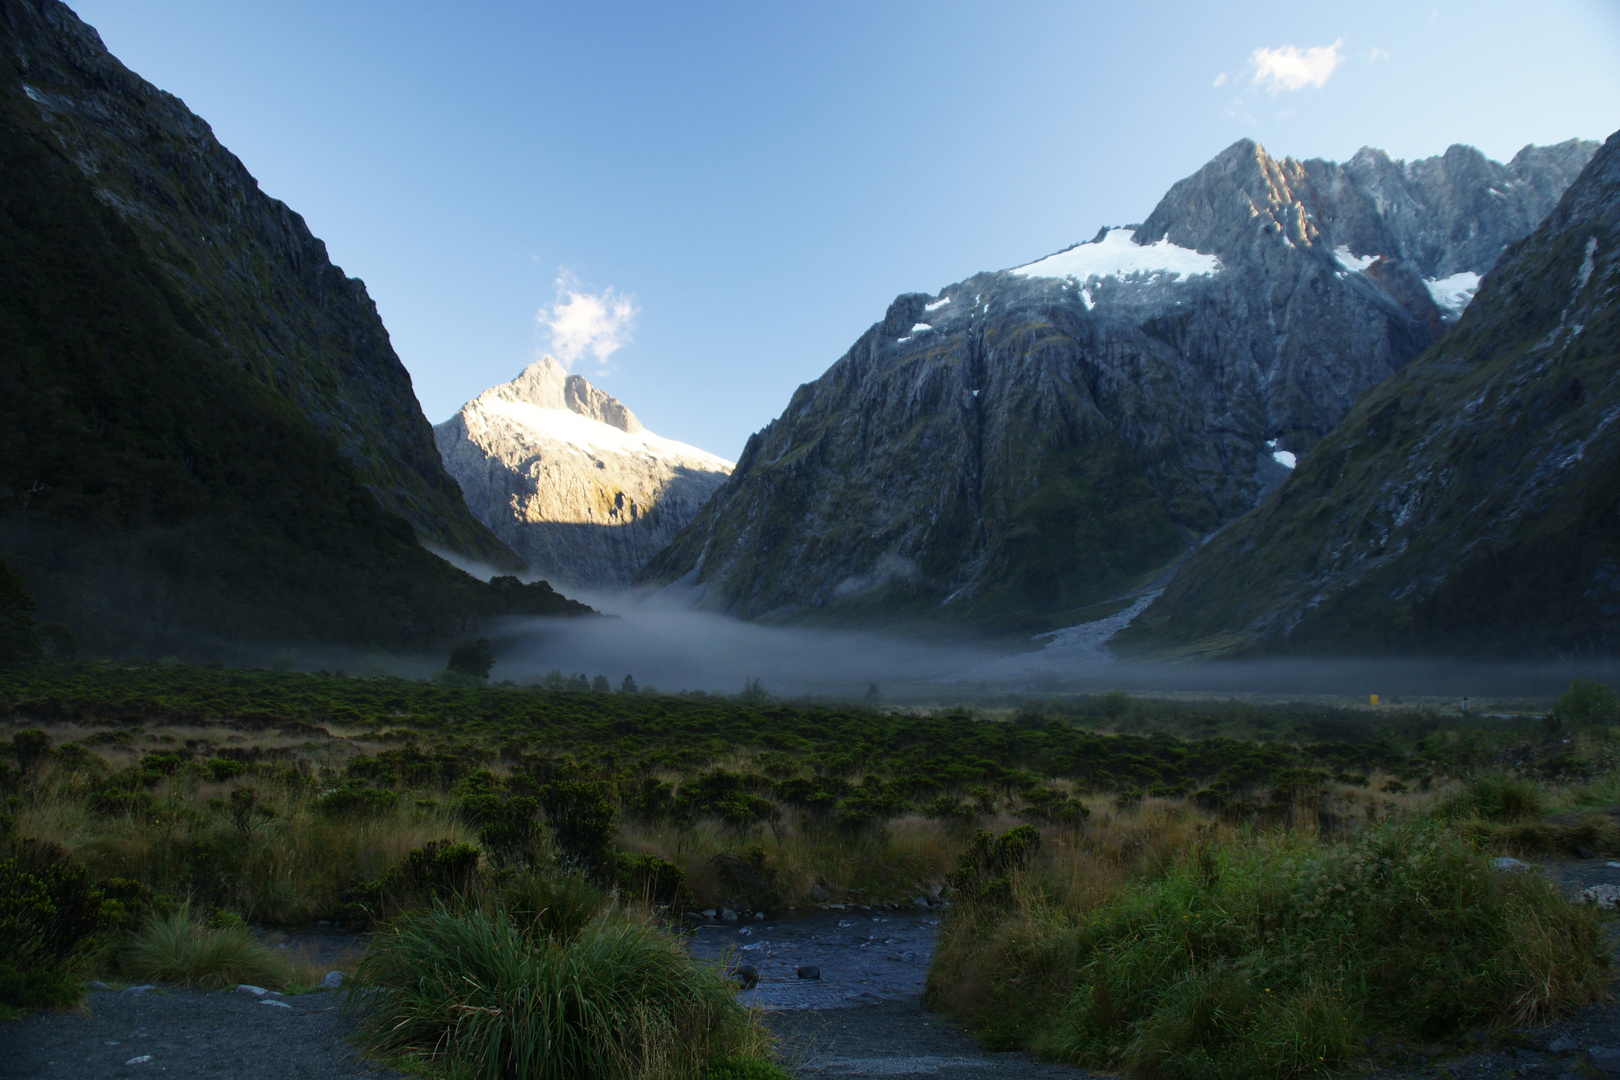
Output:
[{"xmin": 118, "ymin": 905, "xmax": 295, "ymax": 989}]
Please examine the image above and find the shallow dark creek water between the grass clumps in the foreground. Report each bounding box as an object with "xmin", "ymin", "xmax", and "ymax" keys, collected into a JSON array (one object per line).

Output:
[{"xmin": 689, "ymin": 910, "xmax": 940, "ymax": 1009}]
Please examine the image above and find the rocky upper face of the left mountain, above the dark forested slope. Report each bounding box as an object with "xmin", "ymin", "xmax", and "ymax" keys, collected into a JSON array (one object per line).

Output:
[{"xmin": 0, "ymin": 0, "xmax": 518, "ymax": 570}]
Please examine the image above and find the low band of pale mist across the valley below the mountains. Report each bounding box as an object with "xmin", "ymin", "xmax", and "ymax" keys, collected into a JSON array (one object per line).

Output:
[{"xmin": 492, "ymin": 593, "xmax": 1620, "ymax": 704}]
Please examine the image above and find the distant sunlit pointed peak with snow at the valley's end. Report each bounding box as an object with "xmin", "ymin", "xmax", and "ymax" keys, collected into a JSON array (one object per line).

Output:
[{"xmin": 434, "ymin": 356, "xmax": 732, "ymax": 588}]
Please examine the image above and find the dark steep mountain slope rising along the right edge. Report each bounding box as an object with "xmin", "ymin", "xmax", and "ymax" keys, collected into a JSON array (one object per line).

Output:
[{"xmin": 1119, "ymin": 134, "xmax": 1620, "ymax": 657}]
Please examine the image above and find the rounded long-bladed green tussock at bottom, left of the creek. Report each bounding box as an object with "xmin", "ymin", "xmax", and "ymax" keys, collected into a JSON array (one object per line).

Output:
[{"xmin": 350, "ymin": 904, "xmax": 760, "ymax": 1080}]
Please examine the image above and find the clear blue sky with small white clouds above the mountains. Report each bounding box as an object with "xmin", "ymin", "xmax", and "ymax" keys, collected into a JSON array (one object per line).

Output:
[{"xmin": 75, "ymin": 0, "xmax": 1620, "ymax": 458}]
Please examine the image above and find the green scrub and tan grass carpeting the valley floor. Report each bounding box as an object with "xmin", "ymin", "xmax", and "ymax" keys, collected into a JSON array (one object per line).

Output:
[{"xmin": 0, "ymin": 663, "xmax": 1620, "ymax": 1077}]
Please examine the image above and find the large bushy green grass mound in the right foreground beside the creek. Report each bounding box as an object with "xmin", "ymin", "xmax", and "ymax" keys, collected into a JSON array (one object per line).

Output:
[{"xmin": 928, "ymin": 818, "xmax": 1609, "ymax": 1080}]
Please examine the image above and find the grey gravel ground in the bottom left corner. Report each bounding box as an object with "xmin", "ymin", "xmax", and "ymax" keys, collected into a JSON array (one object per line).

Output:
[{"xmin": 0, "ymin": 988, "xmax": 403, "ymax": 1080}]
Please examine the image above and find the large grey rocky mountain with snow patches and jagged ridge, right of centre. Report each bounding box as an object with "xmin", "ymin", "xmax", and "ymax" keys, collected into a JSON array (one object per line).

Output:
[{"xmin": 645, "ymin": 141, "xmax": 1596, "ymax": 631}]
